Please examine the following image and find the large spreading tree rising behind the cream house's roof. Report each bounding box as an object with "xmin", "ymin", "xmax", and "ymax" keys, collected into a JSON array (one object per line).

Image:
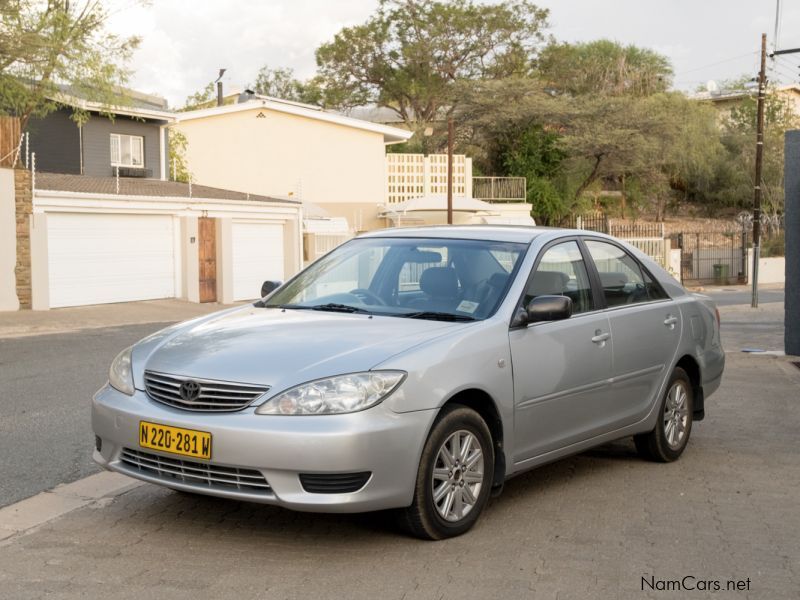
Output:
[{"xmin": 317, "ymin": 0, "xmax": 547, "ymax": 138}]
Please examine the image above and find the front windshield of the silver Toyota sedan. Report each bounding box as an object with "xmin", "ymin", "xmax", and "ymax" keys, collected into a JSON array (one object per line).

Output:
[{"xmin": 265, "ymin": 238, "xmax": 527, "ymax": 321}]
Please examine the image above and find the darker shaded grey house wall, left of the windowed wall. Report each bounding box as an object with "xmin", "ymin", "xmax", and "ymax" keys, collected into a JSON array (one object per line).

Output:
[{"xmin": 27, "ymin": 108, "xmax": 81, "ymax": 175}]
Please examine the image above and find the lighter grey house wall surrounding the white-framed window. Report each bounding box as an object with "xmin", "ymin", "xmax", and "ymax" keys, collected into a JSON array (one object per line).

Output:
[{"xmin": 83, "ymin": 115, "xmax": 162, "ymax": 179}]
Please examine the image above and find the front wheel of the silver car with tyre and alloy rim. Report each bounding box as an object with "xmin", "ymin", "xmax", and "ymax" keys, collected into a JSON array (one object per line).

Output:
[{"xmin": 399, "ymin": 404, "xmax": 494, "ymax": 540}]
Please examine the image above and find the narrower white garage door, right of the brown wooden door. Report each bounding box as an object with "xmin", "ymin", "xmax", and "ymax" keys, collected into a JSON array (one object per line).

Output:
[{"xmin": 231, "ymin": 222, "xmax": 284, "ymax": 300}]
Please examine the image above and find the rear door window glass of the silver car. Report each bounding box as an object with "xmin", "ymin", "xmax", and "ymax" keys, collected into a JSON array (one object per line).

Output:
[{"xmin": 586, "ymin": 240, "xmax": 651, "ymax": 307}]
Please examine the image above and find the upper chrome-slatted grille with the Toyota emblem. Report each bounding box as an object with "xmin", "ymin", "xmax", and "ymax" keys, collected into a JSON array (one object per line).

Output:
[{"xmin": 144, "ymin": 371, "xmax": 269, "ymax": 412}]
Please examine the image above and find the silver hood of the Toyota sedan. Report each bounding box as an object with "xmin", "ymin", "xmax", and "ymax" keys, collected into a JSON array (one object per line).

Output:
[{"xmin": 133, "ymin": 305, "xmax": 462, "ymax": 391}]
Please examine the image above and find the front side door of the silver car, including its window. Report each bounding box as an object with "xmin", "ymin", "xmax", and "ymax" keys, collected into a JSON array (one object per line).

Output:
[{"xmin": 509, "ymin": 241, "xmax": 612, "ymax": 463}]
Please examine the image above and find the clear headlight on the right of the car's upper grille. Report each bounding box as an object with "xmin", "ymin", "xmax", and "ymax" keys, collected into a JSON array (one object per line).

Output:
[{"xmin": 256, "ymin": 371, "xmax": 406, "ymax": 415}]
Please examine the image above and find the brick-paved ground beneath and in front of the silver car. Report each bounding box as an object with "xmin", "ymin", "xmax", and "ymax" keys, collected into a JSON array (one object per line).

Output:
[{"xmin": 0, "ymin": 353, "xmax": 800, "ymax": 600}]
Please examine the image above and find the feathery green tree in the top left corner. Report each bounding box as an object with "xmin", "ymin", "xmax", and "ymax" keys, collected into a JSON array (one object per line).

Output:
[{"xmin": 0, "ymin": 0, "xmax": 139, "ymax": 129}]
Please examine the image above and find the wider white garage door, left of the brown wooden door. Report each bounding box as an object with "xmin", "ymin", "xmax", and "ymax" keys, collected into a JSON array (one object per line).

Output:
[{"xmin": 47, "ymin": 213, "xmax": 175, "ymax": 307}]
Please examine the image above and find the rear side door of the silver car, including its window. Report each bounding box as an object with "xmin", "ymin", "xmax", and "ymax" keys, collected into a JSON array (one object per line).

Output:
[{"xmin": 584, "ymin": 238, "xmax": 682, "ymax": 427}]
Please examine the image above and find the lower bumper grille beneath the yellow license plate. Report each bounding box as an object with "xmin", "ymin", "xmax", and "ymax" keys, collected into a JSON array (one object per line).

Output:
[{"xmin": 120, "ymin": 448, "xmax": 272, "ymax": 495}]
